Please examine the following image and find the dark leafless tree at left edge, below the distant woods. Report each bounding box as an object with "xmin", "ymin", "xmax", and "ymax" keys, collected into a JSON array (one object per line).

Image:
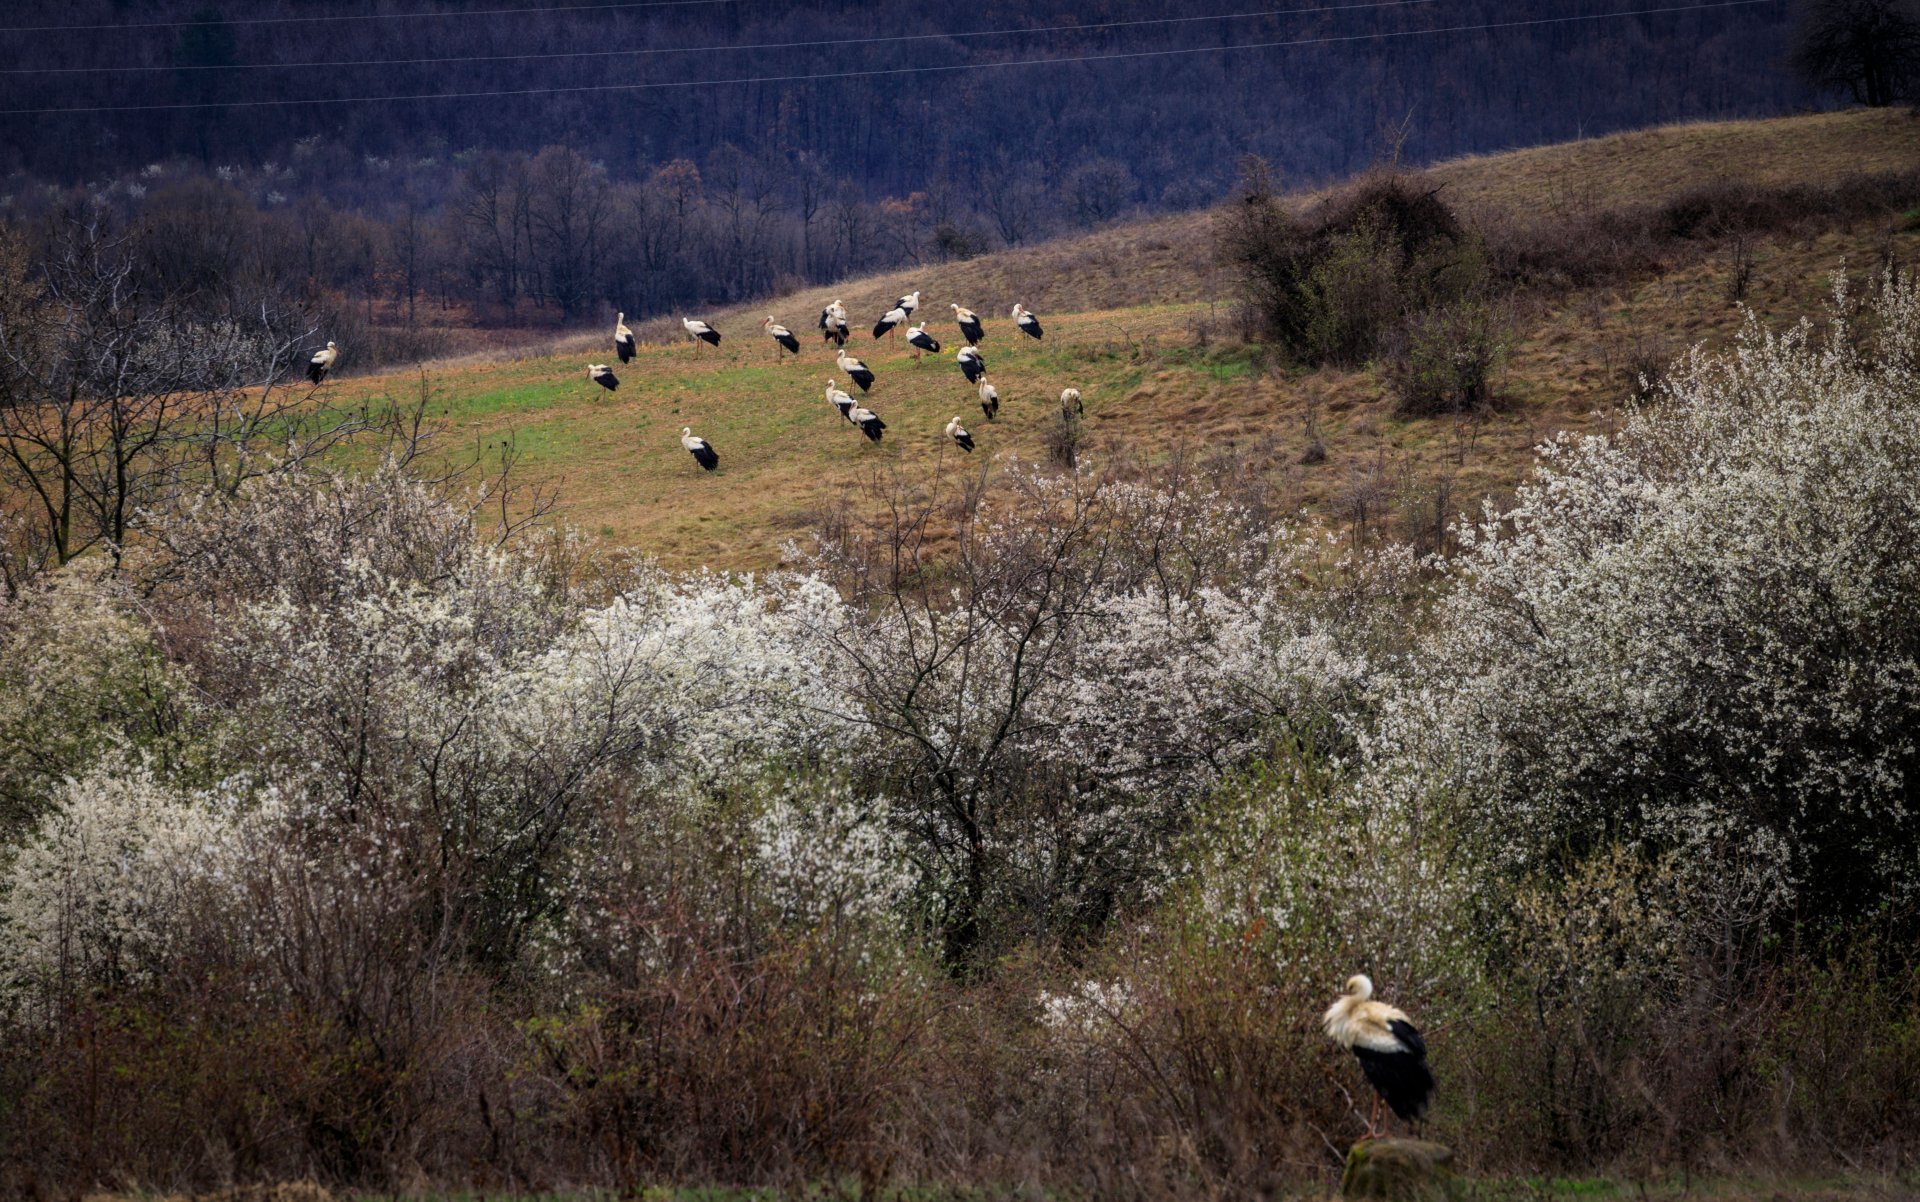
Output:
[{"xmin": 0, "ymin": 215, "xmax": 385, "ymax": 563}]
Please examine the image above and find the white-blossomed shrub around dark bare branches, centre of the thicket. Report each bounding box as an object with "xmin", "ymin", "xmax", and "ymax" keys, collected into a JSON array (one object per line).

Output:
[{"xmin": 812, "ymin": 458, "xmax": 1396, "ymax": 956}]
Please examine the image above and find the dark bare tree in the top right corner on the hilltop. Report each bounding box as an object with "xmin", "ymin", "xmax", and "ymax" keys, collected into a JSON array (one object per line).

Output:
[{"xmin": 1793, "ymin": 0, "xmax": 1920, "ymax": 108}]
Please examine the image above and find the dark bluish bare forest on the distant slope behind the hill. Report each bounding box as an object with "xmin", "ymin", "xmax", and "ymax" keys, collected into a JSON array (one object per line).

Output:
[{"xmin": 0, "ymin": 0, "xmax": 1811, "ymax": 343}]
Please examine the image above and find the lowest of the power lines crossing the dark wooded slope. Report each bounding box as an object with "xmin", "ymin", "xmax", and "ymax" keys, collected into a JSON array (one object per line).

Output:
[{"xmin": 0, "ymin": 0, "xmax": 1782, "ymax": 117}]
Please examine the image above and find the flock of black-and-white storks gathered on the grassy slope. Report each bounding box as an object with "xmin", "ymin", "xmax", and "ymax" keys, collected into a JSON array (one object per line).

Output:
[{"xmin": 588, "ymin": 290, "xmax": 1081, "ymax": 472}]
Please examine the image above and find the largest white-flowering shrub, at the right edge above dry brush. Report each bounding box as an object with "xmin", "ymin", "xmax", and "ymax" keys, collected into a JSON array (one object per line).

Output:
[{"xmin": 1373, "ymin": 270, "xmax": 1920, "ymax": 916}]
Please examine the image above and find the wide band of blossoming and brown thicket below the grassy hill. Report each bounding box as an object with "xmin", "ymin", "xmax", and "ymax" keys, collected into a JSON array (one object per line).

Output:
[{"xmin": 0, "ymin": 278, "xmax": 1920, "ymax": 1198}]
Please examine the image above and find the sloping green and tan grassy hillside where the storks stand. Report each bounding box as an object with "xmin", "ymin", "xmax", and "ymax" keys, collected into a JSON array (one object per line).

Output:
[{"xmin": 334, "ymin": 111, "xmax": 1920, "ymax": 568}]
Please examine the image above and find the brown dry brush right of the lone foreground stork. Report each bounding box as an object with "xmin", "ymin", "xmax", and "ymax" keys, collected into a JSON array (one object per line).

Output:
[{"xmin": 1442, "ymin": 847, "xmax": 1920, "ymax": 1173}]
